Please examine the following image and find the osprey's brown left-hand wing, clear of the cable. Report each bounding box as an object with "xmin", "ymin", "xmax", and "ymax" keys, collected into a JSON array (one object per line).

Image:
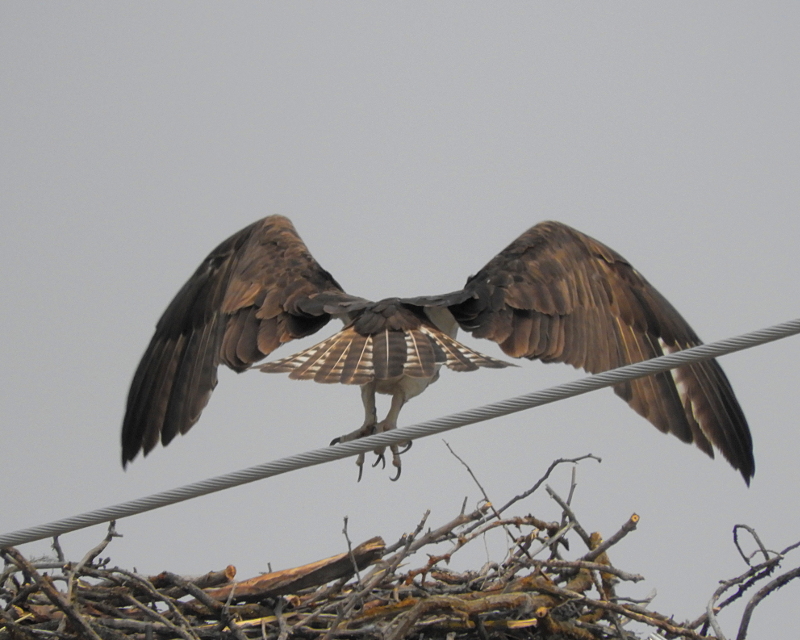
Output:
[{"xmin": 122, "ymin": 216, "xmax": 366, "ymax": 466}]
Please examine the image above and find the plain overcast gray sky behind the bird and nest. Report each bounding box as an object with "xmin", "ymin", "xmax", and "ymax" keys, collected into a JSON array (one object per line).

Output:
[{"xmin": 0, "ymin": 2, "xmax": 800, "ymax": 637}]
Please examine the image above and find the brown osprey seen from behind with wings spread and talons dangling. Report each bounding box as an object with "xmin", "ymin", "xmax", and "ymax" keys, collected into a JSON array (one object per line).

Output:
[{"xmin": 122, "ymin": 216, "xmax": 755, "ymax": 484}]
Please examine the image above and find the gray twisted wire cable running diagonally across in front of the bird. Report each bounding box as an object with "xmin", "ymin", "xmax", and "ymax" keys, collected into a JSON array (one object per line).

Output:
[{"xmin": 0, "ymin": 318, "xmax": 800, "ymax": 548}]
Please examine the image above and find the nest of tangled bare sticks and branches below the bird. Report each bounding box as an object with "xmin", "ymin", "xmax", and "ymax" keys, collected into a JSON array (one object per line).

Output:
[{"xmin": 0, "ymin": 460, "xmax": 800, "ymax": 640}]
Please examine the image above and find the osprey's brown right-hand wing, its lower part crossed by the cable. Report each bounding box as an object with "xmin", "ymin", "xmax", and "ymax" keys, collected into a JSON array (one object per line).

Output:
[{"xmin": 417, "ymin": 222, "xmax": 755, "ymax": 483}]
